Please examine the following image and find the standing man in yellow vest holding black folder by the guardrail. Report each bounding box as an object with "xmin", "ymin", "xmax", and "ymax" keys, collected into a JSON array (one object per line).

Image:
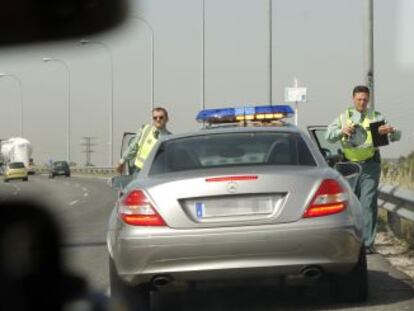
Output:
[{"xmin": 325, "ymin": 86, "xmax": 401, "ymax": 253}]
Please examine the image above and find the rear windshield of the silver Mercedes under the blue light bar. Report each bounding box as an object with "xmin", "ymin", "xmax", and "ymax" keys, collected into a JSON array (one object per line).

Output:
[{"xmin": 150, "ymin": 132, "xmax": 316, "ymax": 175}]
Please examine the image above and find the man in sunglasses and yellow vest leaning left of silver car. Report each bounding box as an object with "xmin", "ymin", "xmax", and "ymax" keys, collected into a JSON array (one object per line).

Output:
[{"xmin": 116, "ymin": 107, "xmax": 171, "ymax": 174}]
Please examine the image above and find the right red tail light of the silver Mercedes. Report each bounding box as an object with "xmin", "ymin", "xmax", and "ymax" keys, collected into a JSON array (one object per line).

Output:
[{"xmin": 303, "ymin": 179, "xmax": 348, "ymax": 218}]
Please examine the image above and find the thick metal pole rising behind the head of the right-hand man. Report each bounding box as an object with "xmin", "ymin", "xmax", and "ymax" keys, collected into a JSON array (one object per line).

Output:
[{"xmin": 366, "ymin": 0, "xmax": 375, "ymax": 109}]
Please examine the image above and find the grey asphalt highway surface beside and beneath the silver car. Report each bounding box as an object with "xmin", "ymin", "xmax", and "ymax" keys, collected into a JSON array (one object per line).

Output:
[{"xmin": 0, "ymin": 176, "xmax": 414, "ymax": 311}]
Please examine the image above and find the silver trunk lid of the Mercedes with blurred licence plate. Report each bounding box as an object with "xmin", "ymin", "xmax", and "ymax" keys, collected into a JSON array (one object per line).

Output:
[{"xmin": 145, "ymin": 166, "xmax": 334, "ymax": 228}]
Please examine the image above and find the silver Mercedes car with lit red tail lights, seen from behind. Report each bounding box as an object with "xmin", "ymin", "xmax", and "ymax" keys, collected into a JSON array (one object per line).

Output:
[{"xmin": 107, "ymin": 106, "xmax": 367, "ymax": 310}]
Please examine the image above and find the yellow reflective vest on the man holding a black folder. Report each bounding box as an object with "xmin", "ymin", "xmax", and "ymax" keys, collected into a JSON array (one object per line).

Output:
[{"xmin": 340, "ymin": 109, "xmax": 376, "ymax": 161}]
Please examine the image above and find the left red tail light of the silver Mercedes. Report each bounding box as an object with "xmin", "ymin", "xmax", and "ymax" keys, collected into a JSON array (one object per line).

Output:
[{"xmin": 118, "ymin": 190, "xmax": 166, "ymax": 226}]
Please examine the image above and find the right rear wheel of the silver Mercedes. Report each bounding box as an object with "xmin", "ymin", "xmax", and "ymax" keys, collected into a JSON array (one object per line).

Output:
[{"xmin": 331, "ymin": 247, "xmax": 368, "ymax": 302}]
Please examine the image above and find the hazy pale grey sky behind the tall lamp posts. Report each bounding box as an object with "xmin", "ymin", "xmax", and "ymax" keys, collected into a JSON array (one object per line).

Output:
[{"xmin": 0, "ymin": 0, "xmax": 414, "ymax": 166}]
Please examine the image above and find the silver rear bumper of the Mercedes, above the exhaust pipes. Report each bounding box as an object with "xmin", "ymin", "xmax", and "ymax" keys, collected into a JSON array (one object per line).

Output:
[{"xmin": 108, "ymin": 224, "xmax": 362, "ymax": 285}]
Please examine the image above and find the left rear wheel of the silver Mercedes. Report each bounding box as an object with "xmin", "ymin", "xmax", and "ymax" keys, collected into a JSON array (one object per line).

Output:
[{"xmin": 109, "ymin": 258, "xmax": 151, "ymax": 311}]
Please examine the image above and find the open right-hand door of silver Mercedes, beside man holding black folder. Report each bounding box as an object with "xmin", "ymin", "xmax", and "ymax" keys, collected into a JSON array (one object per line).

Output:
[{"xmin": 307, "ymin": 125, "xmax": 361, "ymax": 190}]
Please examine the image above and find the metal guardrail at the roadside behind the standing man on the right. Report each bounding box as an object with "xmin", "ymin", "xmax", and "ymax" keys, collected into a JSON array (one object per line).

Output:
[{"xmin": 378, "ymin": 184, "xmax": 414, "ymax": 237}]
